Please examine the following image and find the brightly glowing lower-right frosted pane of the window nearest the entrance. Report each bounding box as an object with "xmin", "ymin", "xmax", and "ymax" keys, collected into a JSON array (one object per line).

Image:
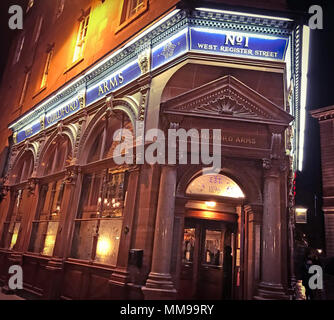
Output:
[{"xmin": 95, "ymin": 219, "xmax": 123, "ymax": 265}]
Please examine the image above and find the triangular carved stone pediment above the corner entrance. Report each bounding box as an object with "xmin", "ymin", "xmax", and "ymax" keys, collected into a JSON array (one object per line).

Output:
[{"xmin": 162, "ymin": 76, "xmax": 293, "ymax": 126}]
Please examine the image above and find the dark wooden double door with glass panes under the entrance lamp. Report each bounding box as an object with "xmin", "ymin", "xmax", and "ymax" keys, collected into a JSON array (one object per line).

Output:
[{"xmin": 179, "ymin": 218, "xmax": 235, "ymax": 300}]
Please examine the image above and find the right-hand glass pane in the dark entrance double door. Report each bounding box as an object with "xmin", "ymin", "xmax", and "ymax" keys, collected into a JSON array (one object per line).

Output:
[{"xmin": 204, "ymin": 230, "xmax": 223, "ymax": 266}]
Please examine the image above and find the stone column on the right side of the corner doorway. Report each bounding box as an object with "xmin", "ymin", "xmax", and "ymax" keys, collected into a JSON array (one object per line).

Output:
[{"xmin": 256, "ymin": 160, "xmax": 287, "ymax": 299}]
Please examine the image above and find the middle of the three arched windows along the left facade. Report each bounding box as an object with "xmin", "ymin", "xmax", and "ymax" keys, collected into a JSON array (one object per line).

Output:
[{"xmin": 28, "ymin": 137, "xmax": 71, "ymax": 256}]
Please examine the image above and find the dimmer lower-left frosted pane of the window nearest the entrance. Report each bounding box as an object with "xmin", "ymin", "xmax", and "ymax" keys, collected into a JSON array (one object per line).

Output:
[{"xmin": 71, "ymin": 220, "xmax": 98, "ymax": 260}]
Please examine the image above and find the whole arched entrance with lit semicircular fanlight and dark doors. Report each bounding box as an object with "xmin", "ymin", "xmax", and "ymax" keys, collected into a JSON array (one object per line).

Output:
[{"xmin": 179, "ymin": 174, "xmax": 245, "ymax": 300}]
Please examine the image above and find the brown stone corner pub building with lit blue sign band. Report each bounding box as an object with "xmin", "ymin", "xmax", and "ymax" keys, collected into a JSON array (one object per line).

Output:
[{"xmin": 0, "ymin": 0, "xmax": 310, "ymax": 299}]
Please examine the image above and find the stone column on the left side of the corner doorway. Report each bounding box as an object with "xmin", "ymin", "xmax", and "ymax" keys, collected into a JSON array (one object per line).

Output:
[{"xmin": 142, "ymin": 165, "xmax": 176, "ymax": 300}]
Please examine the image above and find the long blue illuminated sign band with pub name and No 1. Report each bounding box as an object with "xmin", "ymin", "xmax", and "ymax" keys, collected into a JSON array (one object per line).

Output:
[{"xmin": 14, "ymin": 27, "xmax": 289, "ymax": 143}]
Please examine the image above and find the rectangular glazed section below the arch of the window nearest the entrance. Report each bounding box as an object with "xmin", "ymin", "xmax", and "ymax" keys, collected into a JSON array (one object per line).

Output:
[{"xmin": 71, "ymin": 169, "xmax": 126, "ymax": 265}]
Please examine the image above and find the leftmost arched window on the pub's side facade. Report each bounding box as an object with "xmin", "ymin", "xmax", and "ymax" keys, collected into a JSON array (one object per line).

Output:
[{"xmin": 1, "ymin": 151, "xmax": 34, "ymax": 250}]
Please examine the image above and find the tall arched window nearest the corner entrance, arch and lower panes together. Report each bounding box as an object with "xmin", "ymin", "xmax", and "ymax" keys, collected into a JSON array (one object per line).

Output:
[{"xmin": 71, "ymin": 113, "xmax": 132, "ymax": 265}]
